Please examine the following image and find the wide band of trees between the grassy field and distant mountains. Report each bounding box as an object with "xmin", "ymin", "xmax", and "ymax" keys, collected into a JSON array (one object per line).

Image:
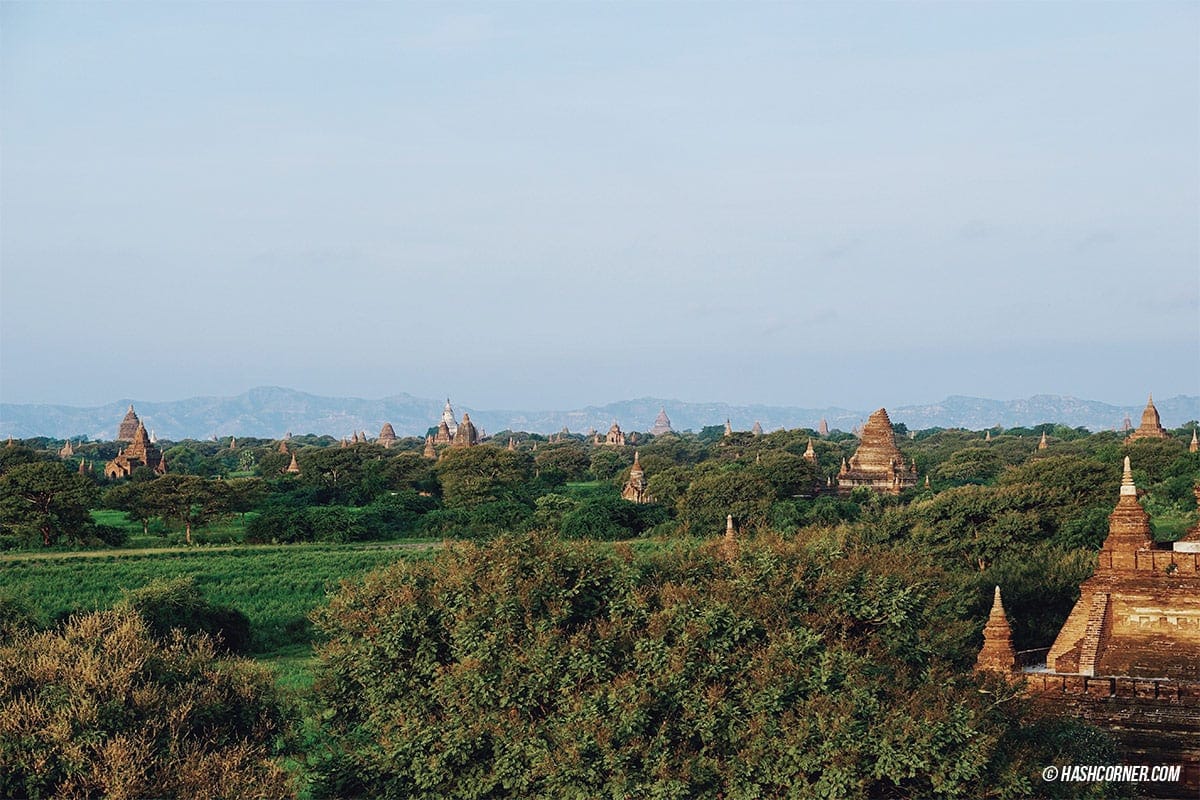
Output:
[{"xmin": 0, "ymin": 426, "xmax": 1198, "ymax": 551}]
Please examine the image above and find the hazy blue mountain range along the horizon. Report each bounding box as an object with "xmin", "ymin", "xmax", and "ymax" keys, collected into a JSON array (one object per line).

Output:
[{"xmin": 0, "ymin": 386, "xmax": 1200, "ymax": 440}]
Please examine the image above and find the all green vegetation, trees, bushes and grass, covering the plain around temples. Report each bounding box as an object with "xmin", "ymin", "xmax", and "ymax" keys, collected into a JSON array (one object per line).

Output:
[{"xmin": 0, "ymin": 425, "xmax": 1200, "ymax": 798}]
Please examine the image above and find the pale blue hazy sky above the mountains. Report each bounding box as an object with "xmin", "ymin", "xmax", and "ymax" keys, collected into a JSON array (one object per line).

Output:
[{"xmin": 0, "ymin": 0, "xmax": 1200, "ymax": 409}]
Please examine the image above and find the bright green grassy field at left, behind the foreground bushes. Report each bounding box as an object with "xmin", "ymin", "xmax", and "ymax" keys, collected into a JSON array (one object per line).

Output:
[{"xmin": 0, "ymin": 545, "xmax": 433, "ymax": 655}]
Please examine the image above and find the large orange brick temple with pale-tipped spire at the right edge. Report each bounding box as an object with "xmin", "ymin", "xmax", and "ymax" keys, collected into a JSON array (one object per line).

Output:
[{"xmin": 977, "ymin": 458, "xmax": 1200, "ymax": 798}]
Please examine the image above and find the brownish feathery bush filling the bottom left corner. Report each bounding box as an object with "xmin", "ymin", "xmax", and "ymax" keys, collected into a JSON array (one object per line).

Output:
[{"xmin": 0, "ymin": 612, "xmax": 293, "ymax": 800}]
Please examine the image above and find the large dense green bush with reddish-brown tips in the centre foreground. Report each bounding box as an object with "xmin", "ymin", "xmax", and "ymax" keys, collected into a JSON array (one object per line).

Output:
[{"xmin": 314, "ymin": 536, "xmax": 1115, "ymax": 799}]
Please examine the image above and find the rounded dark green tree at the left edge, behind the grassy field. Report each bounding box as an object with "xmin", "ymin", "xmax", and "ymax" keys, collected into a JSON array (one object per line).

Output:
[{"xmin": 0, "ymin": 461, "xmax": 100, "ymax": 547}]
